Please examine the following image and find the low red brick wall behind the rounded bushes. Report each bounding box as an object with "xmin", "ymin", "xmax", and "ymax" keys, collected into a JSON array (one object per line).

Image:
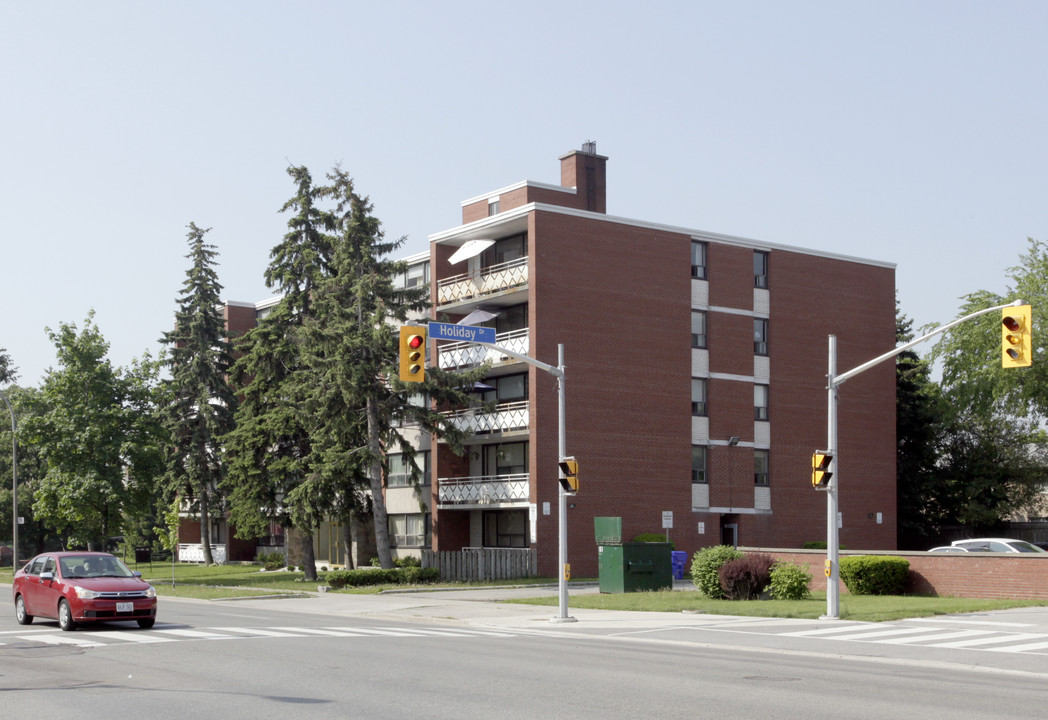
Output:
[{"xmin": 739, "ymin": 547, "xmax": 1048, "ymax": 599}]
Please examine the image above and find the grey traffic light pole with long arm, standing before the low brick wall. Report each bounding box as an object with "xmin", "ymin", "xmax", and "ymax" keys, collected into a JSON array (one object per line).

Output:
[{"xmin": 820, "ymin": 300, "xmax": 1024, "ymax": 620}]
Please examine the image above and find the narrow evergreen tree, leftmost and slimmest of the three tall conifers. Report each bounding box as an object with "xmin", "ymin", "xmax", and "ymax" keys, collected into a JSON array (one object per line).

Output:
[{"xmin": 162, "ymin": 222, "xmax": 237, "ymax": 565}]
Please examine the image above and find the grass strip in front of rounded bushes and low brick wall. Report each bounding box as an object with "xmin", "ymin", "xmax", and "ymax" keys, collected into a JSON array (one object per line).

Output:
[{"xmin": 507, "ymin": 590, "xmax": 1048, "ymax": 623}]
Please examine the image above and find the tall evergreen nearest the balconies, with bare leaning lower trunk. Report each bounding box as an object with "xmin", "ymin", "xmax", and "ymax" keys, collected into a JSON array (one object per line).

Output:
[{"xmin": 293, "ymin": 167, "xmax": 485, "ymax": 568}]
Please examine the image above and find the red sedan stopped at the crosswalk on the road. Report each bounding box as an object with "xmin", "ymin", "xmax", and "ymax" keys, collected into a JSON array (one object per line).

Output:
[{"xmin": 12, "ymin": 552, "xmax": 156, "ymax": 630}]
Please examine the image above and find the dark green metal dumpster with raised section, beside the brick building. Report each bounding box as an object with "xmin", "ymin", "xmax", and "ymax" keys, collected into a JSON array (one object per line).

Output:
[{"xmin": 593, "ymin": 518, "xmax": 673, "ymax": 592}]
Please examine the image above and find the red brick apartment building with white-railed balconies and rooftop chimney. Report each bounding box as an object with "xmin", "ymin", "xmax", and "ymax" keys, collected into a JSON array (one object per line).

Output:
[{"xmin": 430, "ymin": 144, "xmax": 896, "ymax": 576}]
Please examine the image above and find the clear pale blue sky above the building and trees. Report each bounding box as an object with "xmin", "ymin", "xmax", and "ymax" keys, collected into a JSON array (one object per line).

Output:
[{"xmin": 0, "ymin": 0, "xmax": 1048, "ymax": 385}]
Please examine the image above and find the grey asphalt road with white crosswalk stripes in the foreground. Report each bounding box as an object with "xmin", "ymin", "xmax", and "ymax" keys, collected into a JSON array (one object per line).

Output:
[{"xmin": 0, "ymin": 587, "xmax": 1048, "ymax": 720}]
